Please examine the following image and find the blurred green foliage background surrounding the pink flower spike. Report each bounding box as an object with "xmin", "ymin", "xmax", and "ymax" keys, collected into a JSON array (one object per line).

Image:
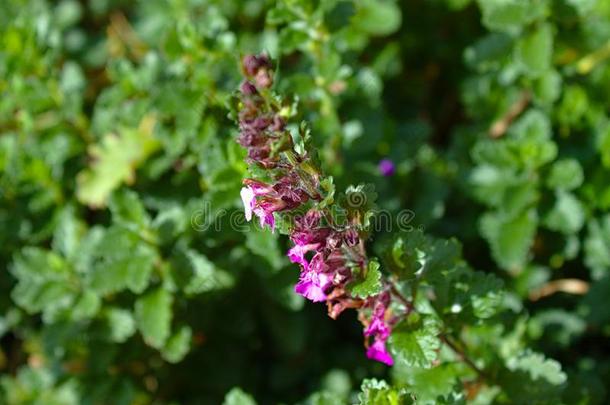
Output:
[{"xmin": 0, "ymin": 0, "xmax": 610, "ymax": 405}]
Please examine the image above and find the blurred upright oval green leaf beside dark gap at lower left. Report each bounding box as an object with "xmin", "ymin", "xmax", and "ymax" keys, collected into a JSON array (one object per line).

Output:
[{"xmin": 135, "ymin": 287, "xmax": 173, "ymax": 349}]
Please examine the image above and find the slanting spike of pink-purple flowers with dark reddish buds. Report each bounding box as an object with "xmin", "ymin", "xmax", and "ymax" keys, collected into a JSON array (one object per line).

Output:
[{"xmin": 233, "ymin": 55, "xmax": 397, "ymax": 365}]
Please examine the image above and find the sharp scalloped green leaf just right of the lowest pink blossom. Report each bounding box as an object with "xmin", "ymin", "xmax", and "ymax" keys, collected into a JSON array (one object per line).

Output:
[{"xmin": 389, "ymin": 315, "xmax": 441, "ymax": 368}]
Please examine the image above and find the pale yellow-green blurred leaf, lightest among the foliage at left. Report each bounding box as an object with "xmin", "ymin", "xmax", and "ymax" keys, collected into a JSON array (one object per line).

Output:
[{"xmin": 76, "ymin": 116, "xmax": 159, "ymax": 207}]
